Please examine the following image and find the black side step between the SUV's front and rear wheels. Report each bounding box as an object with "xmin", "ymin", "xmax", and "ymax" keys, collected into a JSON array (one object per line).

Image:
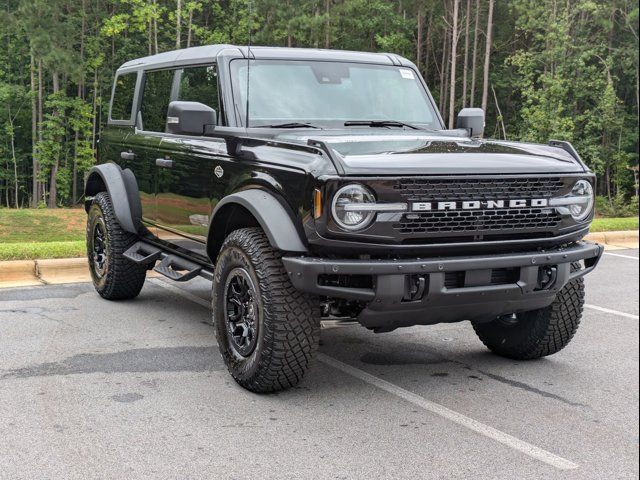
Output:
[{"xmin": 123, "ymin": 241, "xmax": 213, "ymax": 282}]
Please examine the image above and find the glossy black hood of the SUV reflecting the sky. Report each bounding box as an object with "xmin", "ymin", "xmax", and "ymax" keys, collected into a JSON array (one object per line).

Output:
[{"xmin": 277, "ymin": 131, "xmax": 585, "ymax": 175}]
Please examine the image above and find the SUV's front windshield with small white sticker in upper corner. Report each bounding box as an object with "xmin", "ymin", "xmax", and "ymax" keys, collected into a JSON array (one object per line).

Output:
[{"xmin": 231, "ymin": 60, "xmax": 441, "ymax": 129}]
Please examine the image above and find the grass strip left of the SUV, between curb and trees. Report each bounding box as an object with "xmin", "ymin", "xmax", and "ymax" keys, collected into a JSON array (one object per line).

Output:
[{"xmin": 0, "ymin": 208, "xmax": 87, "ymax": 245}]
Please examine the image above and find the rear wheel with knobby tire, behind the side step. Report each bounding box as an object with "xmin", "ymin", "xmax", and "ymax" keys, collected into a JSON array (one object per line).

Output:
[{"xmin": 87, "ymin": 192, "xmax": 147, "ymax": 300}]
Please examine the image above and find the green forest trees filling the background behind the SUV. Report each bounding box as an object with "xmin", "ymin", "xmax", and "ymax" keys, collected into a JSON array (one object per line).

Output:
[{"xmin": 0, "ymin": 0, "xmax": 639, "ymax": 210}]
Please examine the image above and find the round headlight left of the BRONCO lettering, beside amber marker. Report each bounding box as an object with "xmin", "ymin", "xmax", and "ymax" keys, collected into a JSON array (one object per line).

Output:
[{"xmin": 331, "ymin": 183, "xmax": 376, "ymax": 231}]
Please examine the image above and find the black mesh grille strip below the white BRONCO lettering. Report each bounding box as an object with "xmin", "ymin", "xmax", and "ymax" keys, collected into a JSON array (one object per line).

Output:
[{"xmin": 393, "ymin": 208, "xmax": 562, "ymax": 235}]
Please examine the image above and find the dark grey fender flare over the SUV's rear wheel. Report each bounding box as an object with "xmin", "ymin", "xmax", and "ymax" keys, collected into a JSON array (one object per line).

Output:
[{"xmin": 84, "ymin": 163, "xmax": 142, "ymax": 234}]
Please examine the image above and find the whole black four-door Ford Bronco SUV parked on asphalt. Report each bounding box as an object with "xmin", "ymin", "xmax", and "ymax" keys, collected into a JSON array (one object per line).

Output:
[{"xmin": 85, "ymin": 45, "xmax": 602, "ymax": 392}]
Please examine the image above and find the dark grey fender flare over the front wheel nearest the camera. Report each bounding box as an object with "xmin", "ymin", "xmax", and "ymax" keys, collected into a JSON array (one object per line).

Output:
[{"xmin": 209, "ymin": 188, "xmax": 307, "ymax": 253}]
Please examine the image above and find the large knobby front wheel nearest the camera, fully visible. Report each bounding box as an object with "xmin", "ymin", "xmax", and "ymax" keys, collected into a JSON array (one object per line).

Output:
[{"xmin": 212, "ymin": 228, "xmax": 320, "ymax": 392}]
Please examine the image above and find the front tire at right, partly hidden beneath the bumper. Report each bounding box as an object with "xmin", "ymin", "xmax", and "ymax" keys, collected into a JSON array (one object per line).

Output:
[{"xmin": 473, "ymin": 264, "xmax": 584, "ymax": 360}]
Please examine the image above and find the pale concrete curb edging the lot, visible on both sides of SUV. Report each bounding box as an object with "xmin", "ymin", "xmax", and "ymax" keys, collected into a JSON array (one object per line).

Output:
[{"xmin": 0, "ymin": 230, "xmax": 638, "ymax": 288}]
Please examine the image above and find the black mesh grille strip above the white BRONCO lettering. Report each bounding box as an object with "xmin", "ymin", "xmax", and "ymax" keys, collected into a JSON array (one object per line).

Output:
[{"xmin": 394, "ymin": 177, "xmax": 565, "ymax": 202}]
